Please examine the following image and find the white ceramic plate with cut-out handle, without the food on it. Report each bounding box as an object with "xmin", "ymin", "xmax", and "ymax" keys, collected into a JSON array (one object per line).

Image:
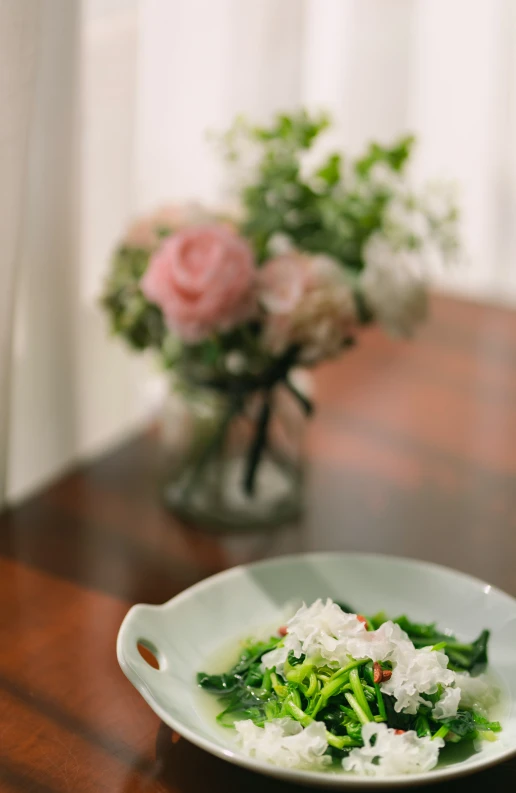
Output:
[{"xmin": 117, "ymin": 553, "xmax": 516, "ymax": 788}]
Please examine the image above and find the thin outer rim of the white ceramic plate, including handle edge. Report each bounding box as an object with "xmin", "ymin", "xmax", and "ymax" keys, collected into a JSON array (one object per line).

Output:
[{"xmin": 116, "ymin": 551, "xmax": 516, "ymax": 789}]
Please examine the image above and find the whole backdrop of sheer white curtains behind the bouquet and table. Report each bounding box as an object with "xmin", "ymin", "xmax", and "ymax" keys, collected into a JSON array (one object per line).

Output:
[{"xmin": 0, "ymin": 0, "xmax": 516, "ymax": 501}]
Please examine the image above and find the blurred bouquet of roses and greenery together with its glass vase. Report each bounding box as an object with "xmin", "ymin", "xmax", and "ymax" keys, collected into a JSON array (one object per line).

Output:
[{"xmin": 102, "ymin": 111, "xmax": 457, "ymax": 527}]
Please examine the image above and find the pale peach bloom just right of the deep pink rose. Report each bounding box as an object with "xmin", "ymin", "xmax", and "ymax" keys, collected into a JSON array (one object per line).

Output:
[{"xmin": 258, "ymin": 251, "xmax": 356, "ymax": 363}]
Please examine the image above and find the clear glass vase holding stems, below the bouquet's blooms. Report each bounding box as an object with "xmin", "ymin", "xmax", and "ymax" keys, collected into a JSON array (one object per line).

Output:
[{"xmin": 159, "ymin": 373, "xmax": 306, "ymax": 531}]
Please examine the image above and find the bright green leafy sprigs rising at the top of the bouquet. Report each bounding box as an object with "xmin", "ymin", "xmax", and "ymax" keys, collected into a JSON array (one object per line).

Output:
[{"xmin": 227, "ymin": 106, "xmax": 414, "ymax": 268}]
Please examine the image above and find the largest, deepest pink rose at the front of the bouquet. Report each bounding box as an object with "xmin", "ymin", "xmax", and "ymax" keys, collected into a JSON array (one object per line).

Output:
[{"xmin": 141, "ymin": 225, "xmax": 256, "ymax": 343}]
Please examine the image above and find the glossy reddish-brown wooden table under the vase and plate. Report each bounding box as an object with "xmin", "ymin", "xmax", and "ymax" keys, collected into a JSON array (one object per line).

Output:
[{"xmin": 0, "ymin": 298, "xmax": 516, "ymax": 793}]
